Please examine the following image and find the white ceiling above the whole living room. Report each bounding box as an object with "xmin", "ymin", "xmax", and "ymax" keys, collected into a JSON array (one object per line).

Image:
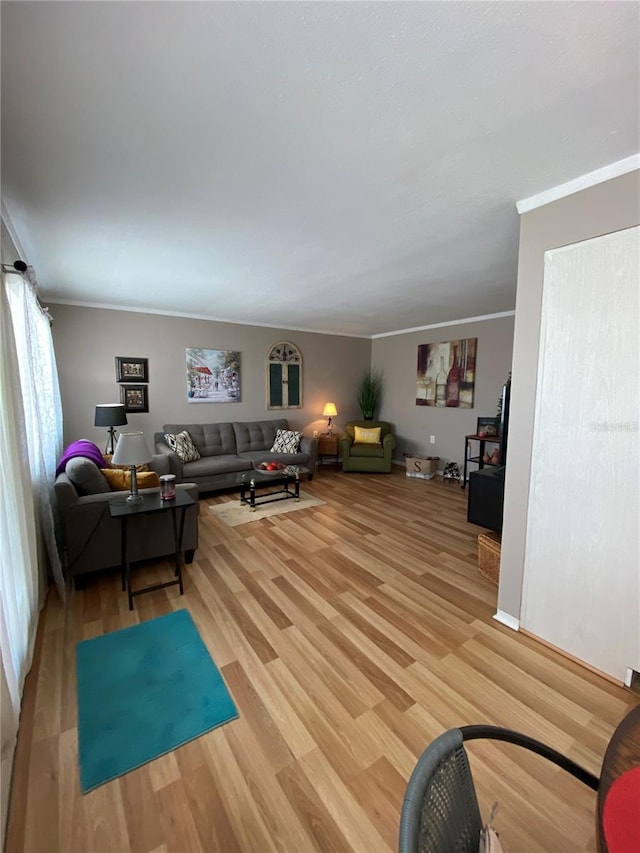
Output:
[{"xmin": 1, "ymin": 0, "xmax": 640, "ymax": 336}]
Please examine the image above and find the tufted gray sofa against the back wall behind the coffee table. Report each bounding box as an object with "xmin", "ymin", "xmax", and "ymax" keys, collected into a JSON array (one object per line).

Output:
[{"xmin": 154, "ymin": 418, "xmax": 318, "ymax": 494}]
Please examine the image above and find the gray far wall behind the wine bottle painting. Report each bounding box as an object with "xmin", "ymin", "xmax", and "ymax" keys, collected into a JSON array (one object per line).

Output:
[{"xmin": 372, "ymin": 316, "xmax": 514, "ymax": 472}]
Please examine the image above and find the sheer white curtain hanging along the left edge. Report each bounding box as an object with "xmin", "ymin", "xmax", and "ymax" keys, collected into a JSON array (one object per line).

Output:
[{"xmin": 0, "ymin": 274, "xmax": 65, "ymax": 844}]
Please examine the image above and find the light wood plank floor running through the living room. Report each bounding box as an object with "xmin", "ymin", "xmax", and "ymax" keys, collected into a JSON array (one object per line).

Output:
[{"xmin": 6, "ymin": 471, "xmax": 638, "ymax": 853}]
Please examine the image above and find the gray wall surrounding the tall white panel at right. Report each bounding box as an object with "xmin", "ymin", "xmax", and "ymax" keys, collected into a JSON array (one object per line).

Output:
[{"xmin": 498, "ymin": 171, "xmax": 640, "ymax": 619}]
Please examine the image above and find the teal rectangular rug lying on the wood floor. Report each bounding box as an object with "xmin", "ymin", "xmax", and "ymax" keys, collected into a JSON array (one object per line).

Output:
[{"xmin": 76, "ymin": 610, "xmax": 238, "ymax": 794}]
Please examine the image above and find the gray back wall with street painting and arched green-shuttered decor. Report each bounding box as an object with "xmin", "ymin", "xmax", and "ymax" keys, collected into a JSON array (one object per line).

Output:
[{"xmin": 50, "ymin": 303, "xmax": 371, "ymax": 449}]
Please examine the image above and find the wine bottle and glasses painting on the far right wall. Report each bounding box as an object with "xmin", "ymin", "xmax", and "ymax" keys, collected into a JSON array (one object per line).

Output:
[{"xmin": 416, "ymin": 338, "xmax": 478, "ymax": 409}]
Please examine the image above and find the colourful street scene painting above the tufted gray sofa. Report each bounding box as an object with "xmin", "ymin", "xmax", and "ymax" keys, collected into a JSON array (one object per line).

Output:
[{"xmin": 187, "ymin": 347, "xmax": 240, "ymax": 403}]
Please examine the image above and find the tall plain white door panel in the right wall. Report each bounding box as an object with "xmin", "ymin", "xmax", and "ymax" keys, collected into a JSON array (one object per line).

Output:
[{"xmin": 521, "ymin": 228, "xmax": 640, "ymax": 681}]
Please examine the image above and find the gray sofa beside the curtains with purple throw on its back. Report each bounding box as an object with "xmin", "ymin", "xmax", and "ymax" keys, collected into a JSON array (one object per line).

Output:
[{"xmin": 54, "ymin": 455, "xmax": 199, "ymax": 586}]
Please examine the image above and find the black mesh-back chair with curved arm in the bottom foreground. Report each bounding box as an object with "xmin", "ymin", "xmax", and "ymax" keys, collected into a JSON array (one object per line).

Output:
[{"xmin": 399, "ymin": 726, "xmax": 598, "ymax": 853}]
